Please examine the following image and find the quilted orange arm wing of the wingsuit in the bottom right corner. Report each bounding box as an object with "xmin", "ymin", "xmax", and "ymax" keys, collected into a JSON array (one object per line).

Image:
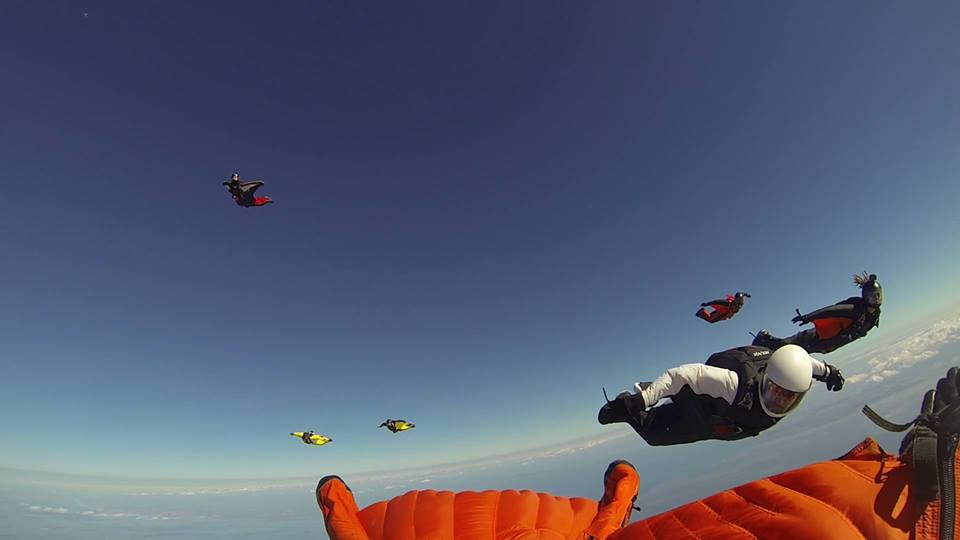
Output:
[{"xmin": 609, "ymin": 438, "xmax": 960, "ymax": 540}]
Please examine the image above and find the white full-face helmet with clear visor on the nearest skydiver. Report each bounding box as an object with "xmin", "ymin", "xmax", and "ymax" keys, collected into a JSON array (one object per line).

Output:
[{"xmin": 760, "ymin": 345, "xmax": 813, "ymax": 418}]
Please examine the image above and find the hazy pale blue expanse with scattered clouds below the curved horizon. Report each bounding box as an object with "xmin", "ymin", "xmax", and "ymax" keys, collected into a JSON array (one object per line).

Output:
[{"xmin": 0, "ymin": 315, "xmax": 960, "ymax": 540}]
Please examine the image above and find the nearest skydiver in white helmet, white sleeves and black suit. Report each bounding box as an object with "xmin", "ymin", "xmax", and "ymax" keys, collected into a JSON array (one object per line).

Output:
[{"xmin": 597, "ymin": 345, "xmax": 844, "ymax": 446}]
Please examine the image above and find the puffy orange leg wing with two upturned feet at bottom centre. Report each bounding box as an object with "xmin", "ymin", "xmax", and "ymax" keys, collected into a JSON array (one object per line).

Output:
[{"xmin": 317, "ymin": 461, "xmax": 640, "ymax": 540}]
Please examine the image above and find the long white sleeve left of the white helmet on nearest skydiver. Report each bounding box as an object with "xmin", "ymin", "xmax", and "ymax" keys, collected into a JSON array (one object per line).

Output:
[{"xmin": 635, "ymin": 364, "xmax": 740, "ymax": 407}]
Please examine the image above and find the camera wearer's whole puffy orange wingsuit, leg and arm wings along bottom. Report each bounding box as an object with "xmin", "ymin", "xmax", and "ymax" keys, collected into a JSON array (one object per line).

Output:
[{"xmin": 317, "ymin": 438, "xmax": 960, "ymax": 540}]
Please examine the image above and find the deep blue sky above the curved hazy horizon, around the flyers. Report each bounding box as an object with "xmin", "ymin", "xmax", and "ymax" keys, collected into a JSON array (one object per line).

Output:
[{"xmin": 0, "ymin": 1, "xmax": 960, "ymax": 486}]
